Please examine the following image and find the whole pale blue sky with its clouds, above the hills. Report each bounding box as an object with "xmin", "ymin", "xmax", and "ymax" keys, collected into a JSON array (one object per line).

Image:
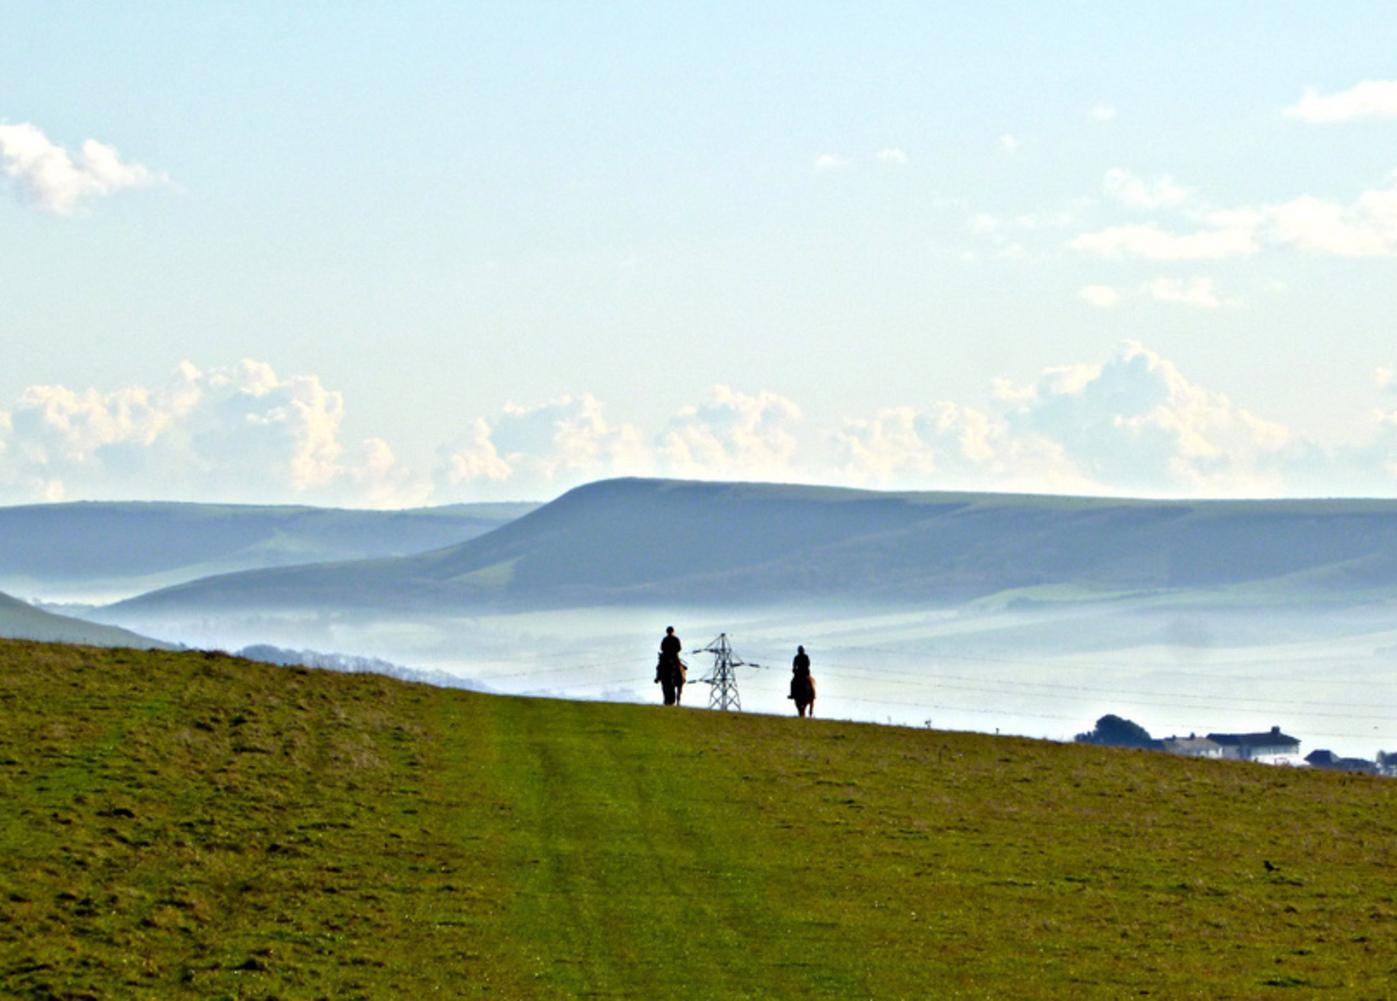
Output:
[{"xmin": 0, "ymin": 0, "xmax": 1397, "ymax": 507}]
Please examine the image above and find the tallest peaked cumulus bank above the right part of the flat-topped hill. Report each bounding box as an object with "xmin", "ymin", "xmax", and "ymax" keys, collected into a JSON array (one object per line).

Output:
[{"xmin": 835, "ymin": 342, "xmax": 1341, "ymax": 496}]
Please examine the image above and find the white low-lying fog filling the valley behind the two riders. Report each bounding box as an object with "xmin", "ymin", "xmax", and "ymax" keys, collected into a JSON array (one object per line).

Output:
[{"xmin": 90, "ymin": 605, "xmax": 1397, "ymax": 758}]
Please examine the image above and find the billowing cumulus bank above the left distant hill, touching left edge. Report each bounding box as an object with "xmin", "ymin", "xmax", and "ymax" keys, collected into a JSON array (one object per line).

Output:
[{"xmin": 0, "ymin": 360, "xmax": 425, "ymax": 503}]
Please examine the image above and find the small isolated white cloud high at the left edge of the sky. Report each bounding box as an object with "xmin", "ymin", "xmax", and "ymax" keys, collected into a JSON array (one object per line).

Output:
[{"xmin": 0, "ymin": 121, "xmax": 168, "ymax": 215}]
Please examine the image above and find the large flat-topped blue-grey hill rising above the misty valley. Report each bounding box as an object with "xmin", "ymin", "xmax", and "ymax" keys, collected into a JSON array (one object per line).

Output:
[{"xmin": 109, "ymin": 479, "xmax": 1397, "ymax": 617}]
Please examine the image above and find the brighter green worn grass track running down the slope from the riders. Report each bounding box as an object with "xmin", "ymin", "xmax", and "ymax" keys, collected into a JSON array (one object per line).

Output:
[{"xmin": 430, "ymin": 699, "xmax": 844, "ymax": 998}]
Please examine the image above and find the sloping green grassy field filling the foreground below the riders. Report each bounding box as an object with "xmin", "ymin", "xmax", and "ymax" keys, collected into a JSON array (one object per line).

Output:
[{"xmin": 0, "ymin": 642, "xmax": 1397, "ymax": 998}]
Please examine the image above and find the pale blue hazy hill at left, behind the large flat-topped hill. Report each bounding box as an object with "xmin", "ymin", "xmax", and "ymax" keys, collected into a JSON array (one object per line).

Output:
[{"xmin": 0, "ymin": 501, "xmax": 536, "ymax": 599}]
